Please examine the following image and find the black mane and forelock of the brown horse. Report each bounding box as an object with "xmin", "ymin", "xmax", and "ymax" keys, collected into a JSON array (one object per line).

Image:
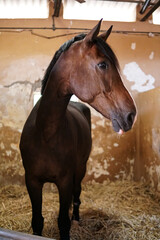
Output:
[{"xmin": 41, "ymin": 33, "xmax": 119, "ymax": 94}]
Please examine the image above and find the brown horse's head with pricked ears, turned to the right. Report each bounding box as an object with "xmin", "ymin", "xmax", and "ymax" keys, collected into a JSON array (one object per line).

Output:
[{"xmin": 57, "ymin": 21, "xmax": 136, "ymax": 133}]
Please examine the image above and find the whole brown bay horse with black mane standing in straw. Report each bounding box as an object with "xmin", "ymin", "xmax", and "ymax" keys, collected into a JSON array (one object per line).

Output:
[{"xmin": 20, "ymin": 20, "xmax": 136, "ymax": 240}]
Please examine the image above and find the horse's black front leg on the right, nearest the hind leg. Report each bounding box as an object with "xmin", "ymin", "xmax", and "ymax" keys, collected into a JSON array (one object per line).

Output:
[{"xmin": 58, "ymin": 178, "xmax": 73, "ymax": 240}]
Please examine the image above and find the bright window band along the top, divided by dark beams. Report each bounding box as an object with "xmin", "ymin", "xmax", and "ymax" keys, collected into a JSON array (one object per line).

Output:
[{"xmin": 0, "ymin": 0, "xmax": 160, "ymax": 24}]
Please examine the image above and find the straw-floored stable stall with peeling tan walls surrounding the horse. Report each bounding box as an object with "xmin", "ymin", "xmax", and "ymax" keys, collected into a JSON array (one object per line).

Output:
[{"xmin": 0, "ymin": 0, "xmax": 160, "ymax": 240}]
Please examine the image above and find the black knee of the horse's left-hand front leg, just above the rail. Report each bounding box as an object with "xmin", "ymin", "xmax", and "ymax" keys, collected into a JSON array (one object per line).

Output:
[{"xmin": 32, "ymin": 216, "xmax": 44, "ymax": 236}]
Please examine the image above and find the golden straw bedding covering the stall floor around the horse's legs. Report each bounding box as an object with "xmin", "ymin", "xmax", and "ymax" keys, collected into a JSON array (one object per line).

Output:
[{"xmin": 0, "ymin": 181, "xmax": 160, "ymax": 240}]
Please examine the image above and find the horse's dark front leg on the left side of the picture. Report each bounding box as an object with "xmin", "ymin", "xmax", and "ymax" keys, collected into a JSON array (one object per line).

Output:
[{"xmin": 25, "ymin": 175, "xmax": 44, "ymax": 236}]
